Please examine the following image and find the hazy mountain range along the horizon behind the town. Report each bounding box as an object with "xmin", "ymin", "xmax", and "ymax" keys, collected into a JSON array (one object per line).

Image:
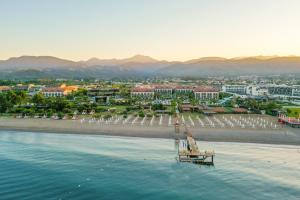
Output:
[{"xmin": 0, "ymin": 55, "xmax": 300, "ymax": 79}]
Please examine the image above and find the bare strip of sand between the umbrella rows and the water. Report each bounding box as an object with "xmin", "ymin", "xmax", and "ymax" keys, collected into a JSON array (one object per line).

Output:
[{"xmin": 0, "ymin": 118, "xmax": 300, "ymax": 145}]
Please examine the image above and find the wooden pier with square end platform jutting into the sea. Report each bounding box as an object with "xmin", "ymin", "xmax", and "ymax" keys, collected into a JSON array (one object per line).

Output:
[{"xmin": 175, "ymin": 116, "xmax": 215, "ymax": 165}]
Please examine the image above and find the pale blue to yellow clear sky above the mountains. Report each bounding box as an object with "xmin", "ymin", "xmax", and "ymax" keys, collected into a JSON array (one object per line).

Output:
[{"xmin": 0, "ymin": 0, "xmax": 300, "ymax": 61}]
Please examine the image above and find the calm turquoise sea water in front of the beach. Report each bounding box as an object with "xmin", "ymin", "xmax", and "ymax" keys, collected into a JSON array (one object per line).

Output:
[{"xmin": 0, "ymin": 131, "xmax": 300, "ymax": 200}]
